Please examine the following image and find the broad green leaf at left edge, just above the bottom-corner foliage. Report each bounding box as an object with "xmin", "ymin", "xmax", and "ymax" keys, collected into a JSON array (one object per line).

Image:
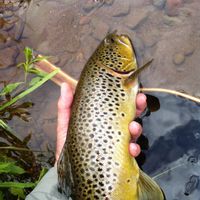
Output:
[{"xmin": 0, "ymin": 162, "xmax": 26, "ymax": 174}]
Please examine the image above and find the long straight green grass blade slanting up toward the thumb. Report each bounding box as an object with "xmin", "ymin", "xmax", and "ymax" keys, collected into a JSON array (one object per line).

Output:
[{"xmin": 0, "ymin": 68, "xmax": 60, "ymax": 111}]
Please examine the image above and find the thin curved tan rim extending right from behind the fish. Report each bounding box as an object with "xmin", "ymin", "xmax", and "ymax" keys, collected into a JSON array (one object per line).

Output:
[{"xmin": 139, "ymin": 88, "xmax": 200, "ymax": 103}]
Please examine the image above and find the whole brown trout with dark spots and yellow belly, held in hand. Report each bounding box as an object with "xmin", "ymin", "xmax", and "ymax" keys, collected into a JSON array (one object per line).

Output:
[{"xmin": 58, "ymin": 33, "xmax": 164, "ymax": 200}]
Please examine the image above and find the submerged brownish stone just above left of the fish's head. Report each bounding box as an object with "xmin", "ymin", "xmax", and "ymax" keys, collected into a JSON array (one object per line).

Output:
[{"xmin": 92, "ymin": 18, "xmax": 109, "ymax": 41}]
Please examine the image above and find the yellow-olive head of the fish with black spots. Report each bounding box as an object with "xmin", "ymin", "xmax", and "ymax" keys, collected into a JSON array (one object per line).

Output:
[{"xmin": 97, "ymin": 32, "xmax": 137, "ymax": 73}]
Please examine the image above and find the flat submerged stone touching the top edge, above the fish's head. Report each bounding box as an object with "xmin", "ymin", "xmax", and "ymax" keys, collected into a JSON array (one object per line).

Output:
[{"xmin": 112, "ymin": 1, "xmax": 130, "ymax": 17}]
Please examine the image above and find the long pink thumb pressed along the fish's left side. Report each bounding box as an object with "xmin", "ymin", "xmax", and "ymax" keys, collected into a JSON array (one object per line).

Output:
[{"xmin": 56, "ymin": 83, "xmax": 73, "ymax": 161}]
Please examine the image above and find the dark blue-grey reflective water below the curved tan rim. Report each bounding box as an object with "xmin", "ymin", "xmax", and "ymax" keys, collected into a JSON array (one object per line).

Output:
[{"xmin": 138, "ymin": 94, "xmax": 200, "ymax": 200}]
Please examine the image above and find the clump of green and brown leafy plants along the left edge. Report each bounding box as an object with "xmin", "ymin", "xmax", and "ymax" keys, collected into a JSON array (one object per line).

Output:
[{"xmin": 0, "ymin": 47, "xmax": 59, "ymax": 200}]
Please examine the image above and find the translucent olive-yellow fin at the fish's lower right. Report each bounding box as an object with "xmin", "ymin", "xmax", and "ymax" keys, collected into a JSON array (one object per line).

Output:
[{"xmin": 138, "ymin": 170, "xmax": 165, "ymax": 200}]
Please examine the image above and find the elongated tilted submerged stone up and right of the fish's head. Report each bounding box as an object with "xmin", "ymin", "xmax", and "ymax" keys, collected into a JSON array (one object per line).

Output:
[{"xmin": 125, "ymin": 9, "xmax": 149, "ymax": 29}]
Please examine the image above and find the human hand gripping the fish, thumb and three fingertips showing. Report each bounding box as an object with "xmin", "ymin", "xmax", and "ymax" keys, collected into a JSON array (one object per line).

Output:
[{"xmin": 56, "ymin": 83, "xmax": 147, "ymax": 162}]
